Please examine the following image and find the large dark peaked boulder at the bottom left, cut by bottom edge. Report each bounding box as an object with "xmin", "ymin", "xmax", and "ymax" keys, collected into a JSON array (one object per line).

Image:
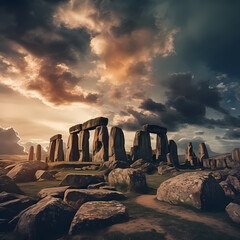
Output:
[{"xmin": 15, "ymin": 197, "xmax": 75, "ymax": 240}]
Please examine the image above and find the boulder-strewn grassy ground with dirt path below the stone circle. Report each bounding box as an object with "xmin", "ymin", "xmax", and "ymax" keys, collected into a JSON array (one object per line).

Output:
[{"xmin": 0, "ymin": 157, "xmax": 240, "ymax": 240}]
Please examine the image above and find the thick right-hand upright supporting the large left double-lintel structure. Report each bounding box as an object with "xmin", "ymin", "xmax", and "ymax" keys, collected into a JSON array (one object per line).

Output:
[{"xmin": 93, "ymin": 126, "xmax": 109, "ymax": 162}]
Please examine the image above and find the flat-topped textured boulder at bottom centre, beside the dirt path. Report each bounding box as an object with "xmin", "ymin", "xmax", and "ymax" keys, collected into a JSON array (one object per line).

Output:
[{"xmin": 69, "ymin": 201, "xmax": 128, "ymax": 234}]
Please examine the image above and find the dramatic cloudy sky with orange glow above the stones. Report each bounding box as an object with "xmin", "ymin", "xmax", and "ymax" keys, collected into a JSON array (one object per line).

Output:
[{"xmin": 0, "ymin": 0, "xmax": 240, "ymax": 153}]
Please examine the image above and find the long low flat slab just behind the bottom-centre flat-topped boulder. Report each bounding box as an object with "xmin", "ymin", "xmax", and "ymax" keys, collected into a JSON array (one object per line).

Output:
[{"xmin": 64, "ymin": 189, "xmax": 126, "ymax": 209}]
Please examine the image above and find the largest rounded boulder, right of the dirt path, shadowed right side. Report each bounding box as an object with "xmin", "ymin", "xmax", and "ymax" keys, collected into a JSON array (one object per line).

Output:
[{"xmin": 157, "ymin": 172, "xmax": 226, "ymax": 210}]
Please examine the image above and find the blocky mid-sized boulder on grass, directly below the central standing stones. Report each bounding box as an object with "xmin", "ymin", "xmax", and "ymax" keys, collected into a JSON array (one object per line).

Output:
[{"xmin": 108, "ymin": 168, "xmax": 147, "ymax": 192}]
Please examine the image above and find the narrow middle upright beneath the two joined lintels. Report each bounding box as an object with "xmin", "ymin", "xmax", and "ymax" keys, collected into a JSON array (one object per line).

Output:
[{"xmin": 78, "ymin": 130, "xmax": 90, "ymax": 162}]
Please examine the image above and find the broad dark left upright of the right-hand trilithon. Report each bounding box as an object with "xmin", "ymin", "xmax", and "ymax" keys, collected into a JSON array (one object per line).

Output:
[{"xmin": 132, "ymin": 130, "xmax": 152, "ymax": 162}]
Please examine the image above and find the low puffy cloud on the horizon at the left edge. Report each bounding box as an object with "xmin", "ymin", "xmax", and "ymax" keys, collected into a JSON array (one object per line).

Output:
[{"xmin": 0, "ymin": 128, "xmax": 25, "ymax": 154}]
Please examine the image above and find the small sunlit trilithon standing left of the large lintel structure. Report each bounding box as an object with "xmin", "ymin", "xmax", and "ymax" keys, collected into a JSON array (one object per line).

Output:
[{"xmin": 46, "ymin": 134, "xmax": 64, "ymax": 162}]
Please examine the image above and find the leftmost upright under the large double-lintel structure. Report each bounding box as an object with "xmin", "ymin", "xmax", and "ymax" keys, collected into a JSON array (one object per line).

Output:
[{"xmin": 66, "ymin": 133, "xmax": 79, "ymax": 162}]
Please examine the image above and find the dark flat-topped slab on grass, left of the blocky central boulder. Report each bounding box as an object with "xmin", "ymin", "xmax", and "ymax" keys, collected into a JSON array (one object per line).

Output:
[{"xmin": 60, "ymin": 173, "xmax": 104, "ymax": 188}]
